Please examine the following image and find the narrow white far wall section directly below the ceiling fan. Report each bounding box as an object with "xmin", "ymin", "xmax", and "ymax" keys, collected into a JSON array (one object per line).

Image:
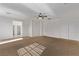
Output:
[{"xmin": 29, "ymin": 19, "xmax": 43, "ymax": 36}]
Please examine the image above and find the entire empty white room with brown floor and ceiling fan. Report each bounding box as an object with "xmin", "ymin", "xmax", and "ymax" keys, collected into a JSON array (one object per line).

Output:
[{"xmin": 0, "ymin": 3, "xmax": 79, "ymax": 56}]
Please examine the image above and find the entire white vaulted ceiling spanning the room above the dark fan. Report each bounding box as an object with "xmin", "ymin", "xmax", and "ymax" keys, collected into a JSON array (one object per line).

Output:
[{"xmin": 0, "ymin": 3, "xmax": 79, "ymax": 20}]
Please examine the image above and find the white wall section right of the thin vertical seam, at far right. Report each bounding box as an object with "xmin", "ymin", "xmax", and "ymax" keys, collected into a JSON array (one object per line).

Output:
[{"xmin": 69, "ymin": 19, "xmax": 79, "ymax": 41}]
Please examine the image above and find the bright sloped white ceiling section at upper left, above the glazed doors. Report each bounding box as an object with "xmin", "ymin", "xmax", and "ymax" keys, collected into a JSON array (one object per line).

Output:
[{"xmin": 0, "ymin": 5, "xmax": 26, "ymax": 19}]
